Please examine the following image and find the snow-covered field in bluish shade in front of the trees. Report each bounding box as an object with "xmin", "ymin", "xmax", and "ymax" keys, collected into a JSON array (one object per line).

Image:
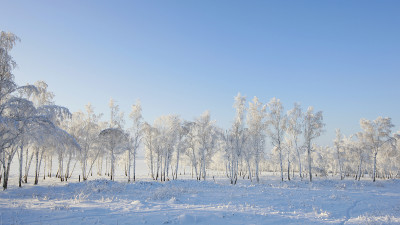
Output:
[{"xmin": 0, "ymin": 159, "xmax": 400, "ymax": 224}]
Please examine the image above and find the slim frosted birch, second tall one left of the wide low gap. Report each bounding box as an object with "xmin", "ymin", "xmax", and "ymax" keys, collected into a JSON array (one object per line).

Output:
[{"xmin": 286, "ymin": 103, "xmax": 303, "ymax": 179}]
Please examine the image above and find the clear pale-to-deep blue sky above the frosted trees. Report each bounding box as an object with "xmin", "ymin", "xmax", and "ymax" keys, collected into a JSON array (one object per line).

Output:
[{"xmin": 0, "ymin": 0, "xmax": 400, "ymax": 144}]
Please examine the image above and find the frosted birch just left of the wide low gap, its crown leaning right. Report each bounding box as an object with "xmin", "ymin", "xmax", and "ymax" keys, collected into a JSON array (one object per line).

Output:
[{"xmin": 303, "ymin": 106, "xmax": 325, "ymax": 181}]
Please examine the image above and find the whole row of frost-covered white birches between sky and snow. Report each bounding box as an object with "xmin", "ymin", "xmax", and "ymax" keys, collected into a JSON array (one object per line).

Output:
[{"xmin": 0, "ymin": 31, "xmax": 400, "ymax": 189}]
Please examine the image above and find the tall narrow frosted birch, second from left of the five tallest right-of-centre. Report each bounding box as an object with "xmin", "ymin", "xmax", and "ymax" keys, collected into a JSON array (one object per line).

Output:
[{"xmin": 247, "ymin": 97, "xmax": 267, "ymax": 182}]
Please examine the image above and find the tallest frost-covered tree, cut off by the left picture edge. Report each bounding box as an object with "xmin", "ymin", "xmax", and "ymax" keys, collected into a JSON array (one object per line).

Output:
[{"xmin": 0, "ymin": 31, "xmax": 53, "ymax": 189}]
